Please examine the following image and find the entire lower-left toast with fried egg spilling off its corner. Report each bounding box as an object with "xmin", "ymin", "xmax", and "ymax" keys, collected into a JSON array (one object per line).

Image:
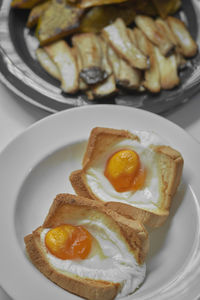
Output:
[{"xmin": 24, "ymin": 194, "xmax": 149, "ymax": 300}]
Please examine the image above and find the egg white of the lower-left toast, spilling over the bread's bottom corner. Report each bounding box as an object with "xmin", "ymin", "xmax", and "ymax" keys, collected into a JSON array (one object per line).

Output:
[{"xmin": 41, "ymin": 219, "xmax": 146, "ymax": 298}]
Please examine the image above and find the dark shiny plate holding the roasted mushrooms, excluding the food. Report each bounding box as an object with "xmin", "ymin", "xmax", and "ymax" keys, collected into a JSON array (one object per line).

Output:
[{"xmin": 0, "ymin": 0, "xmax": 200, "ymax": 113}]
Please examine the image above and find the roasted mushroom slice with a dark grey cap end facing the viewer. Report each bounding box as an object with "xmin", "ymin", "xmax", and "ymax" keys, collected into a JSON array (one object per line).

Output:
[{"xmin": 72, "ymin": 33, "xmax": 108, "ymax": 84}]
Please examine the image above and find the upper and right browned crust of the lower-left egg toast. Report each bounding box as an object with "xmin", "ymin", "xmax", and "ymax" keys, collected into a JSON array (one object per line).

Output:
[{"xmin": 43, "ymin": 194, "xmax": 149, "ymax": 264}]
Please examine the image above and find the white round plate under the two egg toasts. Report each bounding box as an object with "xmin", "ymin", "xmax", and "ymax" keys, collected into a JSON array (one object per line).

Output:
[{"xmin": 0, "ymin": 105, "xmax": 200, "ymax": 300}]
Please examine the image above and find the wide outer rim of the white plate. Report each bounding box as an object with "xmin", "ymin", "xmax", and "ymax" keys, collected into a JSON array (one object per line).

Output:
[{"xmin": 0, "ymin": 105, "xmax": 200, "ymax": 300}]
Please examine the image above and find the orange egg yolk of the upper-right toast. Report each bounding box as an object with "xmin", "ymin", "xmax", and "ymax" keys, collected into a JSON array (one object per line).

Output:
[{"xmin": 104, "ymin": 150, "xmax": 146, "ymax": 192}]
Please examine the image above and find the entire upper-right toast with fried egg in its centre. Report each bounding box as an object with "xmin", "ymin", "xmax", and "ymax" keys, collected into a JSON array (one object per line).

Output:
[{"xmin": 70, "ymin": 127, "xmax": 183, "ymax": 227}]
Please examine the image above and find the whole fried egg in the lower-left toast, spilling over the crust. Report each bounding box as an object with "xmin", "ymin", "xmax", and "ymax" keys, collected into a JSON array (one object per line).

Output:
[{"xmin": 40, "ymin": 219, "xmax": 146, "ymax": 298}]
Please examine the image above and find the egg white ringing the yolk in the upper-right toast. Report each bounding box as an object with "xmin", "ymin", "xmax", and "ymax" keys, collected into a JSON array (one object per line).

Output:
[{"xmin": 85, "ymin": 131, "xmax": 165, "ymax": 210}]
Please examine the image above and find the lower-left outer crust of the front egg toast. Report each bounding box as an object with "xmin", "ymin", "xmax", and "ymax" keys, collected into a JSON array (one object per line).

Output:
[{"xmin": 24, "ymin": 227, "xmax": 119, "ymax": 300}]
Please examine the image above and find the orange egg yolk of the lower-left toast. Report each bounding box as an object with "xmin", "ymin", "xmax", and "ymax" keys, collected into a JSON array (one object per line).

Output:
[{"xmin": 45, "ymin": 224, "xmax": 92, "ymax": 259}]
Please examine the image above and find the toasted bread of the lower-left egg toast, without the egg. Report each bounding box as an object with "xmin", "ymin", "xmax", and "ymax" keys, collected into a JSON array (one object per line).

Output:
[{"xmin": 24, "ymin": 194, "xmax": 149, "ymax": 300}]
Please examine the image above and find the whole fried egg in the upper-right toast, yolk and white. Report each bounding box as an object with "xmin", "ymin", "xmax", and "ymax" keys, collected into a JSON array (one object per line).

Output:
[{"xmin": 85, "ymin": 131, "xmax": 165, "ymax": 210}]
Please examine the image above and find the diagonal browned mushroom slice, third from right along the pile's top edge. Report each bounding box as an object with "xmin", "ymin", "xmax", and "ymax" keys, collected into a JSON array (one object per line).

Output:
[{"xmin": 135, "ymin": 15, "xmax": 174, "ymax": 56}]
